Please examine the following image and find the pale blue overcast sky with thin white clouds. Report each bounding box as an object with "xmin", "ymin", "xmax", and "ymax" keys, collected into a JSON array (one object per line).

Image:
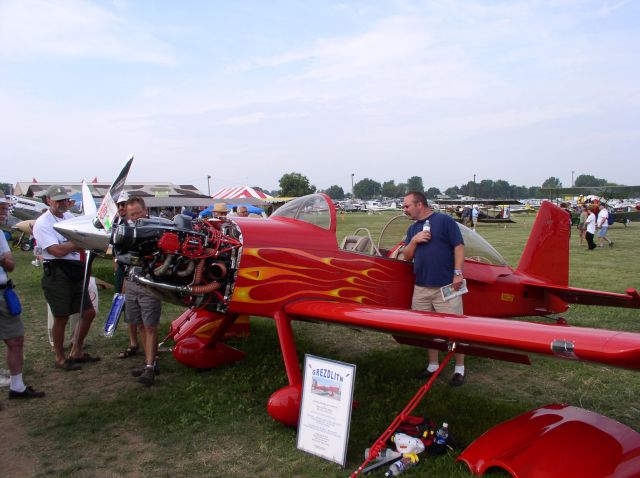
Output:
[{"xmin": 0, "ymin": 0, "xmax": 640, "ymax": 192}]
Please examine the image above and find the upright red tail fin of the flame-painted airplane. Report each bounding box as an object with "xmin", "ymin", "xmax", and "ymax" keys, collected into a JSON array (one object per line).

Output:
[{"xmin": 516, "ymin": 201, "xmax": 571, "ymax": 286}]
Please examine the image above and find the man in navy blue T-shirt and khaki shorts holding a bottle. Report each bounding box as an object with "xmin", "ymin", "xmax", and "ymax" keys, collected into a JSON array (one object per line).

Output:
[{"xmin": 402, "ymin": 192, "xmax": 464, "ymax": 386}]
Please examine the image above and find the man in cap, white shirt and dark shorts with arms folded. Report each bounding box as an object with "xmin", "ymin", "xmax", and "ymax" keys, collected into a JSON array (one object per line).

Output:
[{"xmin": 33, "ymin": 185, "xmax": 100, "ymax": 371}]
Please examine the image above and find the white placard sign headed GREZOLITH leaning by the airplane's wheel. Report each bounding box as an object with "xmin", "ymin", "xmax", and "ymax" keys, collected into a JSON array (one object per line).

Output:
[{"xmin": 297, "ymin": 354, "xmax": 356, "ymax": 466}]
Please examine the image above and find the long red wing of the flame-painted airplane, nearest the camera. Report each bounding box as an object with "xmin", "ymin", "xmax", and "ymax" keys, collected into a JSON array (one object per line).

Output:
[{"xmin": 284, "ymin": 300, "xmax": 640, "ymax": 369}]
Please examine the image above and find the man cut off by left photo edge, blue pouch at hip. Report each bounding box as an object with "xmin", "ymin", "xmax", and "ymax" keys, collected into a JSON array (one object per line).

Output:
[{"xmin": 0, "ymin": 191, "xmax": 44, "ymax": 399}]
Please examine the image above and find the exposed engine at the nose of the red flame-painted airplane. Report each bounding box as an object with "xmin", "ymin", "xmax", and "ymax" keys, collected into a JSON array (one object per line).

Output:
[{"xmin": 112, "ymin": 215, "xmax": 242, "ymax": 313}]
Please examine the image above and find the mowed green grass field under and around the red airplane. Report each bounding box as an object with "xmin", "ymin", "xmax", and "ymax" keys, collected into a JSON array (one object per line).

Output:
[{"xmin": 0, "ymin": 214, "xmax": 640, "ymax": 477}]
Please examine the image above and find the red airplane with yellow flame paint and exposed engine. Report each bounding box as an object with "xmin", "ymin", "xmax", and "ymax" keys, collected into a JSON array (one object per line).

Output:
[{"xmin": 56, "ymin": 164, "xmax": 640, "ymax": 474}]
